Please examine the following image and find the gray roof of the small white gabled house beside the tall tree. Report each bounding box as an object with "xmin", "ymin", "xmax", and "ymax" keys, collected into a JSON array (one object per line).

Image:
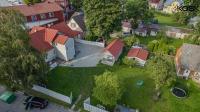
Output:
[{"xmin": 71, "ymin": 12, "xmax": 86, "ymax": 31}]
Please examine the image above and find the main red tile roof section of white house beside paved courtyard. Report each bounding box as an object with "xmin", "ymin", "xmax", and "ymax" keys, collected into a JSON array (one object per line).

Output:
[{"xmin": 29, "ymin": 26, "xmax": 58, "ymax": 52}]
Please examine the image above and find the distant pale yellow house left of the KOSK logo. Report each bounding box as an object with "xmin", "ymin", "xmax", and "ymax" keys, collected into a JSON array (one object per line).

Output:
[{"xmin": 163, "ymin": 0, "xmax": 184, "ymax": 14}]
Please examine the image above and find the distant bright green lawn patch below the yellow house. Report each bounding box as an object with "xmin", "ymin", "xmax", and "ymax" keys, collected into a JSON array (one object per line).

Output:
[{"xmin": 155, "ymin": 13, "xmax": 187, "ymax": 28}]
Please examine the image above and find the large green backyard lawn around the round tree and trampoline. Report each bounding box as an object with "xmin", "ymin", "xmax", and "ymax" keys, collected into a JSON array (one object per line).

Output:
[{"xmin": 48, "ymin": 65, "xmax": 200, "ymax": 112}]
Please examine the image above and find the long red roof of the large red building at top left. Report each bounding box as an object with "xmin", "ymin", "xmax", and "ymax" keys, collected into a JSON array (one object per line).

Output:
[{"xmin": 11, "ymin": 2, "xmax": 63, "ymax": 16}]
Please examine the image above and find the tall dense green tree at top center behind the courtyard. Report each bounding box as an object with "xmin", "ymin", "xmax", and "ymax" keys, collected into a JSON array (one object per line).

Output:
[{"xmin": 83, "ymin": 0, "xmax": 121, "ymax": 38}]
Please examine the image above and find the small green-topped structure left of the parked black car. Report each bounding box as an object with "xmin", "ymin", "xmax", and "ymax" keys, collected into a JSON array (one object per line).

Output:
[{"xmin": 0, "ymin": 91, "xmax": 16, "ymax": 104}]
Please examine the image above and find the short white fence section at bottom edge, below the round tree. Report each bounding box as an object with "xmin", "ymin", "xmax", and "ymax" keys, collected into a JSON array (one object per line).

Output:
[{"xmin": 83, "ymin": 98, "xmax": 109, "ymax": 112}]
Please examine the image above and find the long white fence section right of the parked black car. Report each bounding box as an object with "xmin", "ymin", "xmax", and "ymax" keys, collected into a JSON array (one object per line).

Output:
[{"xmin": 32, "ymin": 85, "xmax": 72, "ymax": 104}]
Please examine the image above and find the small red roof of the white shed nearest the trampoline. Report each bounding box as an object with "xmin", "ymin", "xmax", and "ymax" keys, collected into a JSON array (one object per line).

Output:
[{"xmin": 127, "ymin": 48, "xmax": 149, "ymax": 61}]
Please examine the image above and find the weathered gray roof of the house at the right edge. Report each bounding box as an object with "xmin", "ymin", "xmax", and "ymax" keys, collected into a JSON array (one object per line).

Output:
[{"xmin": 180, "ymin": 44, "xmax": 200, "ymax": 72}]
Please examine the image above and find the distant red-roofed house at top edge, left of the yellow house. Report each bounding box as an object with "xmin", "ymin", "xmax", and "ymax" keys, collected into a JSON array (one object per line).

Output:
[{"xmin": 149, "ymin": 0, "xmax": 163, "ymax": 9}]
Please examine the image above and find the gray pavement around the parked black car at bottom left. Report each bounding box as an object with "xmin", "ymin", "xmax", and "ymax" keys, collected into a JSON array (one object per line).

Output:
[{"xmin": 0, "ymin": 86, "xmax": 69, "ymax": 112}]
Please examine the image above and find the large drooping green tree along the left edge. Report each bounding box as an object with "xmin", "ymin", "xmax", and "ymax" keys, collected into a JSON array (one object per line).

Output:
[{"xmin": 0, "ymin": 9, "xmax": 48, "ymax": 88}]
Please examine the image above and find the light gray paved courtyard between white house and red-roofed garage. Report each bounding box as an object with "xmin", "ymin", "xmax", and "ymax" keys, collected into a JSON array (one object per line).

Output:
[{"xmin": 61, "ymin": 42, "xmax": 104, "ymax": 67}]
